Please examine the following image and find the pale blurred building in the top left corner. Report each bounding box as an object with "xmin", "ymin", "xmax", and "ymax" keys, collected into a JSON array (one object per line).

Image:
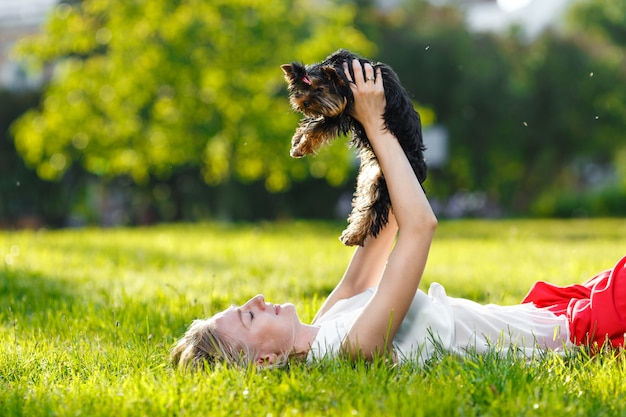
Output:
[{"xmin": 0, "ymin": 0, "xmax": 58, "ymax": 91}]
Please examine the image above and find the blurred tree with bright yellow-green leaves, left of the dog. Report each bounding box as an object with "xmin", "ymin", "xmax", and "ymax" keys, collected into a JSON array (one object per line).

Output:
[{"xmin": 13, "ymin": 0, "xmax": 374, "ymax": 191}]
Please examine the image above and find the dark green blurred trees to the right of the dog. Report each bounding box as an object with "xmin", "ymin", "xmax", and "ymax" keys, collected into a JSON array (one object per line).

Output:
[{"xmin": 370, "ymin": 0, "xmax": 626, "ymax": 213}]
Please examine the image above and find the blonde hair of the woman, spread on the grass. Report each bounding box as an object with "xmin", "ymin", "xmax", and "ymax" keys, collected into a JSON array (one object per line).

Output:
[{"xmin": 171, "ymin": 317, "xmax": 256, "ymax": 370}]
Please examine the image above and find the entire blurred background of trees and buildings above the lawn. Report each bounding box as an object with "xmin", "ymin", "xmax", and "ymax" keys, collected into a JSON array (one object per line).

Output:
[{"xmin": 0, "ymin": 0, "xmax": 626, "ymax": 228}]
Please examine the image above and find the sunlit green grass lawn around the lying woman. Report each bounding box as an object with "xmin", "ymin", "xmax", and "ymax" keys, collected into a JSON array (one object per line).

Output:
[{"xmin": 0, "ymin": 219, "xmax": 626, "ymax": 417}]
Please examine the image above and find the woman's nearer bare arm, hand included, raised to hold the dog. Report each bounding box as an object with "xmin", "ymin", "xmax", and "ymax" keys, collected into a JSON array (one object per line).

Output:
[{"xmin": 343, "ymin": 60, "xmax": 437, "ymax": 358}]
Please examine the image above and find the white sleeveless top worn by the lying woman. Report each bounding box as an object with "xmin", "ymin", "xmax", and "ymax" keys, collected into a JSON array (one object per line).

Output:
[{"xmin": 307, "ymin": 283, "xmax": 574, "ymax": 363}]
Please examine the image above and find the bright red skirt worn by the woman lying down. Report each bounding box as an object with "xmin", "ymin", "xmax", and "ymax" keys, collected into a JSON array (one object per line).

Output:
[{"xmin": 522, "ymin": 256, "xmax": 626, "ymax": 348}]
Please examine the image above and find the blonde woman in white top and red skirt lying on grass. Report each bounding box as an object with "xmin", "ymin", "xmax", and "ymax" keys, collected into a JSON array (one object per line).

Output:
[{"xmin": 172, "ymin": 61, "xmax": 626, "ymax": 369}]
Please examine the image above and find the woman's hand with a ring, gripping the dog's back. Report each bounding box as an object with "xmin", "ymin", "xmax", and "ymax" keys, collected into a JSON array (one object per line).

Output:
[{"xmin": 343, "ymin": 59, "xmax": 386, "ymax": 130}]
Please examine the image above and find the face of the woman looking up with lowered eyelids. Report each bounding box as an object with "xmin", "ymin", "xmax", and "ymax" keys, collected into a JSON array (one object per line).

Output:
[{"xmin": 215, "ymin": 294, "xmax": 300, "ymax": 361}]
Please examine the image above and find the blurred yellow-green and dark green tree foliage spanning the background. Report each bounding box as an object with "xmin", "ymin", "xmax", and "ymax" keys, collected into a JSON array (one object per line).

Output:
[{"xmin": 7, "ymin": 0, "xmax": 626, "ymax": 223}]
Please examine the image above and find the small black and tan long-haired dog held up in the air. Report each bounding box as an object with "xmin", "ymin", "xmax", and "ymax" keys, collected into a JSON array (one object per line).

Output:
[{"xmin": 281, "ymin": 49, "xmax": 427, "ymax": 246}]
